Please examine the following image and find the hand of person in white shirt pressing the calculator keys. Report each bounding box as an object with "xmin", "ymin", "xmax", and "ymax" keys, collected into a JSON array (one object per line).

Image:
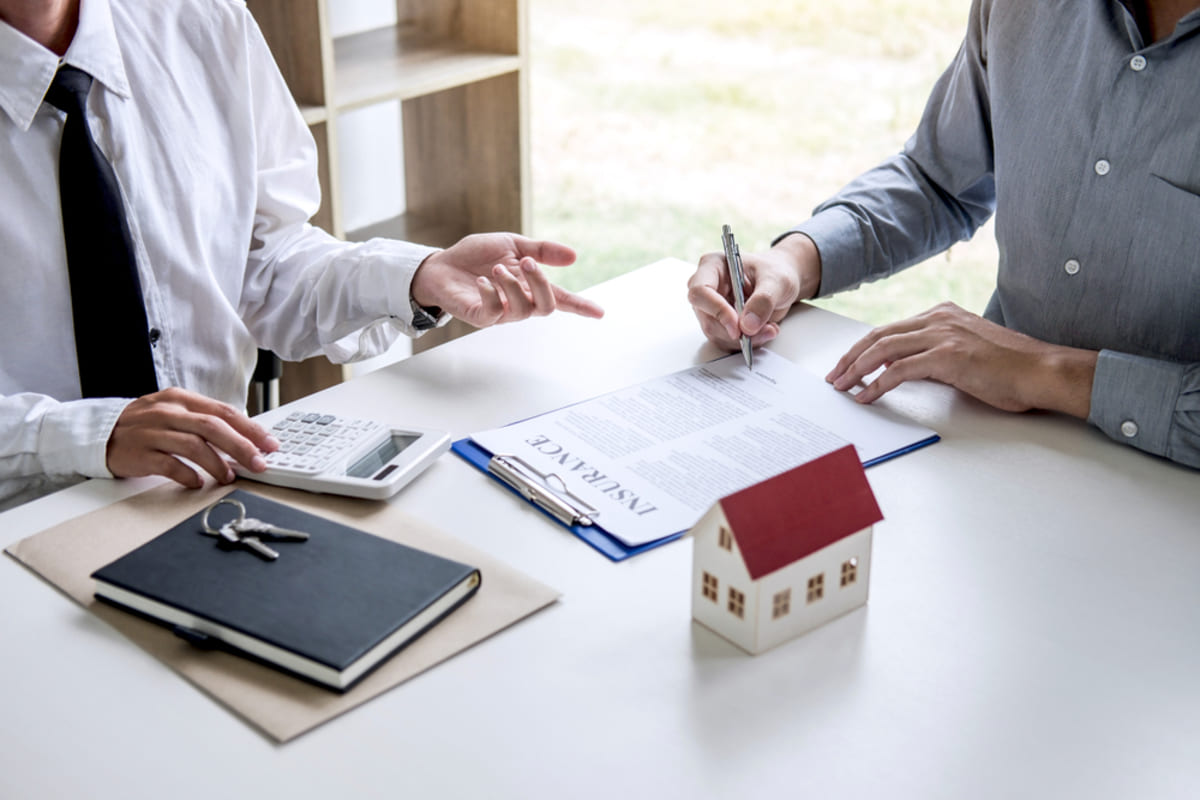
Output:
[{"xmin": 108, "ymin": 389, "xmax": 280, "ymax": 489}]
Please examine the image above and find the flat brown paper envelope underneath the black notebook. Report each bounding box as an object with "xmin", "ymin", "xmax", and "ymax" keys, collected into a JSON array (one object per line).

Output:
[{"xmin": 6, "ymin": 481, "xmax": 559, "ymax": 742}]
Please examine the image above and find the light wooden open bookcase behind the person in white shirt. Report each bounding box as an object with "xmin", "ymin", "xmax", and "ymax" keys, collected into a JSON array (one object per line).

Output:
[{"xmin": 247, "ymin": 0, "xmax": 530, "ymax": 402}]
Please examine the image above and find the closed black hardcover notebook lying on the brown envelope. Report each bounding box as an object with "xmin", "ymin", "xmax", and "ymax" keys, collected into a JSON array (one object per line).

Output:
[{"xmin": 91, "ymin": 489, "xmax": 481, "ymax": 691}]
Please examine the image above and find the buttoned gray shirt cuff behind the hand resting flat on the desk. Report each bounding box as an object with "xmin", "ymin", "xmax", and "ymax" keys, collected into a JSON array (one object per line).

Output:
[{"xmin": 1087, "ymin": 350, "xmax": 1183, "ymax": 456}]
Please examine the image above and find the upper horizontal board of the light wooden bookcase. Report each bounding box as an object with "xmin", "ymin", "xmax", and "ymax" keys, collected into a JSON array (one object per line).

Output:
[{"xmin": 334, "ymin": 26, "xmax": 521, "ymax": 110}]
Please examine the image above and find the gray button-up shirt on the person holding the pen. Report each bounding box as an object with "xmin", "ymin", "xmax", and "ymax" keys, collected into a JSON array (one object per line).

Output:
[{"xmin": 794, "ymin": 0, "xmax": 1200, "ymax": 467}]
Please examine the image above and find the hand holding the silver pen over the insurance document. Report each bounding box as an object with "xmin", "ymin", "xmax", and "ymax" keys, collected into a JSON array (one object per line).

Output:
[{"xmin": 688, "ymin": 234, "xmax": 821, "ymax": 350}]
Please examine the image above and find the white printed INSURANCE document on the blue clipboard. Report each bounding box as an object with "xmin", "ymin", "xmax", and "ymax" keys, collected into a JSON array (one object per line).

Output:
[{"xmin": 472, "ymin": 350, "xmax": 937, "ymax": 546}]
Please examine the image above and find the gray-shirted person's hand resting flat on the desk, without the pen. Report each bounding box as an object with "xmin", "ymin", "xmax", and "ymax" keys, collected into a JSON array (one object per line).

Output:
[{"xmin": 826, "ymin": 302, "xmax": 1098, "ymax": 419}]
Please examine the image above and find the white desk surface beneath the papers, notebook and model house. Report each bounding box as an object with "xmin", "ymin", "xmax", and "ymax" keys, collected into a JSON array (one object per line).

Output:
[{"xmin": 0, "ymin": 261, "xmax": 1200, "ymax": 800}]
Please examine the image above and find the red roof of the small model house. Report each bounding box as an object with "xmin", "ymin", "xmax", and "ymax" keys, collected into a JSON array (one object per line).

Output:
[{"xmin": 720, "ymin": 445, "xmax": 883, "ymax": 581}]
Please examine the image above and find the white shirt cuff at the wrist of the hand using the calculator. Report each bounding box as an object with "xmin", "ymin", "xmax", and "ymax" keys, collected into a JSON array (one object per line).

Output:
[{"xmin": 37, "ymin": 397, "xmax": 133, "ymax": 477}]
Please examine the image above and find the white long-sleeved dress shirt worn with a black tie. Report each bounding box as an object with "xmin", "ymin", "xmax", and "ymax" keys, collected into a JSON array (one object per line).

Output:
[{"xmin": 0, "ymin": 0, "xmax": 433, "ymax": 509}]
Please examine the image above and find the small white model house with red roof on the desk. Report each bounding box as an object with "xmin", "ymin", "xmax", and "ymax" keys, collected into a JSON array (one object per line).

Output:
[{"xmin": 691, "ymin": 446, "xmax": 883, "ymax": 654}]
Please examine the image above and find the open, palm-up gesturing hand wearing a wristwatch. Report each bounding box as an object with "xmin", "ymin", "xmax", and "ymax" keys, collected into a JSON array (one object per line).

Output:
[{"xmin": 412, "ymin": 234, "xmax": 604, "ymax": 327}]
